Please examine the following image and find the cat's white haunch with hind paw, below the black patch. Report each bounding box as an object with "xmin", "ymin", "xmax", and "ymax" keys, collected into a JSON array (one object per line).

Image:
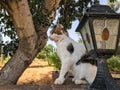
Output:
[{"xmin": 72, "ymin": 63, "xmax": 97, "ymax": 84}]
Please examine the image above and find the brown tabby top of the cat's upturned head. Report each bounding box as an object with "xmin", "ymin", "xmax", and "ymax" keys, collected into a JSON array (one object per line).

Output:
[{"xmin": 50, "ymin": 24, "xmax": 68, "ymax": 36}]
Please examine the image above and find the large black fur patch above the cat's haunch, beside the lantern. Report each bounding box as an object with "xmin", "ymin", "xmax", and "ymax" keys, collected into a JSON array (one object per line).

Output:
[{"xmin": 76, "ymin": 54, "xmax": 97, "ymax": 66}]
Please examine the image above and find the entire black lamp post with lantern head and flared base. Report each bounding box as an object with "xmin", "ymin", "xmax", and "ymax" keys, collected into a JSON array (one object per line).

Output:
[{"xmin": 76, "ymin": 0, "xmax": 120, "ymax": 90}]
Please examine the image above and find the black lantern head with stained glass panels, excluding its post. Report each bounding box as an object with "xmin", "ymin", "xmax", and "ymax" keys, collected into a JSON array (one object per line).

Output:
[{"xmin": 76, "ymin": 5, "xmax": 120, "ymax": 57}]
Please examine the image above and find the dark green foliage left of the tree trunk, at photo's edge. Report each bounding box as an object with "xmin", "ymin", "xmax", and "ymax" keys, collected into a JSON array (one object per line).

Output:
[{"xmin": 0, "ymin": 6, "xmax": 18, "ymax": 55}]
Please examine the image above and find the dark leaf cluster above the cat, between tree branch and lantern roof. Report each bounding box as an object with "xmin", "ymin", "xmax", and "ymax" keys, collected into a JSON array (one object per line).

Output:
[{"xmin": 58, "ymin": 0, "xmax": 84, "ymax": 30}]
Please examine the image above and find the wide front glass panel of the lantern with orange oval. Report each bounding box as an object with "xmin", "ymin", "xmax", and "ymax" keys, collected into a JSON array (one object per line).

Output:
[{"xmin": 93, "ymin": 18, "xmax": 119, "ymax": 49}]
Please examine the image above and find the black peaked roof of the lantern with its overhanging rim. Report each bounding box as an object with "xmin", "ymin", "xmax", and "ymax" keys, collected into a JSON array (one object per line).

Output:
[{"xmin": 76, "ymin": 4, "xmax": 120, "ymax": 31}]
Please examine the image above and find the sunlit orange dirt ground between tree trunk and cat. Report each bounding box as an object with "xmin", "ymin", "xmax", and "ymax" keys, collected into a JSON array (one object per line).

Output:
[{"xmin": 17, "ymin": 60, "xmax": 54, "ymax": 85}]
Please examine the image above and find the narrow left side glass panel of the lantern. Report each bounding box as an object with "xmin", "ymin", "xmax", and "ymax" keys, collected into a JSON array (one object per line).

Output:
[{"xmin": 81, "ymin": 21, "xmax": 94, "ymax": 52}]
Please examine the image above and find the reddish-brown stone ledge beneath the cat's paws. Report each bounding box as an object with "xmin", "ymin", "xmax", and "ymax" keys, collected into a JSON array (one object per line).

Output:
[{"xmin": 51, "ymin": 71, "xmax": 88, "ymax": 90}]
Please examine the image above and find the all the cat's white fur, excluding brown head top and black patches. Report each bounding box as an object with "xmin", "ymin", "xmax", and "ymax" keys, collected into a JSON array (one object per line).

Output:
[{"xmin": 50, "ymin": 34, "xmax": 97, "ymax": 84}]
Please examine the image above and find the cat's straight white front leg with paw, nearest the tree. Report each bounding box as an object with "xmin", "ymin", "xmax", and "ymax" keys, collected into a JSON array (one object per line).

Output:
[{"xmin": 54, "ymin": 63, "xmax": 70, "ymax": 84}]
